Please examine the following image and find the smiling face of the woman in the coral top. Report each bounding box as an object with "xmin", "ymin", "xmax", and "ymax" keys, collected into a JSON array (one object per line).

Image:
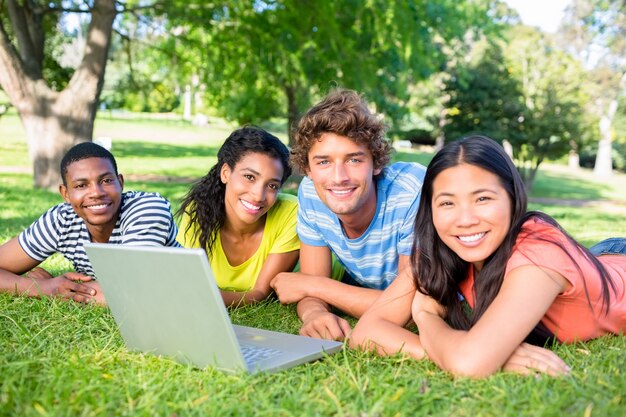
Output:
[{"xmin": 431, "ymin": 164, "xmax": 512, "ymax": 271}]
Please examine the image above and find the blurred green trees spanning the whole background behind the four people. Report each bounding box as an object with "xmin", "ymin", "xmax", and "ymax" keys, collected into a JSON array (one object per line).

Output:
[{"xmin": 0, "ymin": 0, "xmax": 626, "ymax": 188}]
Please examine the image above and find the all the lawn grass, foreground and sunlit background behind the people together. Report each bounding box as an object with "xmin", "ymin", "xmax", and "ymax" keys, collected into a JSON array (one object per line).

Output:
[{"xmin": 0, "ymin": 112, "xmax": 626, "ymax": 416}]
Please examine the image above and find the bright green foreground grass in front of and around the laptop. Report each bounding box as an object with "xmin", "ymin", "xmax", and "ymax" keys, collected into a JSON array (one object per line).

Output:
[{"xmin": 0, "ymin": 294, "xmax": 626, "ymax": 416}]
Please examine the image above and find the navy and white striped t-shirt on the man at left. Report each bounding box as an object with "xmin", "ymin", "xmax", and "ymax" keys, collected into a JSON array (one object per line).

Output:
[{"xmin": 18, "ymin": 191, "xmax": 180, "ymax": 277}]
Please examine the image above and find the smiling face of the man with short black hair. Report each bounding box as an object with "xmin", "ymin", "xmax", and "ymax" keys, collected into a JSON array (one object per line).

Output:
[{"xmin": 59, "ymin": 158, "xmax": 124, "ymax": 236}]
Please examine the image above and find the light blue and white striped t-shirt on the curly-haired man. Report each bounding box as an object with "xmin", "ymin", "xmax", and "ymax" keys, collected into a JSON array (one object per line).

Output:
[{"xmin": 297, "ymin": 162, "xmax": 426, "ymax": 289}]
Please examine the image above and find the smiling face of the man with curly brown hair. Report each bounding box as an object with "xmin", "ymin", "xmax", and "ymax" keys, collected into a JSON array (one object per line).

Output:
[{"xmin": 307, "ymin": 132, "xmax": 381, "ymax": 224}]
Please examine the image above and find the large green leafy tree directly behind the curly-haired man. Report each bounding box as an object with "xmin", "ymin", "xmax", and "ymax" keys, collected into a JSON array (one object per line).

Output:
[{"xmin": 172, "ymin": 0, "xmax": 488, "ymax": 143}]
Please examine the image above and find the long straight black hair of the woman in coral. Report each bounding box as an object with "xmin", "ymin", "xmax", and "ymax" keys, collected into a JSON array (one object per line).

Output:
[{"xmin": 411, "ymin": 135, "xmax": 615, "ymax": 330}]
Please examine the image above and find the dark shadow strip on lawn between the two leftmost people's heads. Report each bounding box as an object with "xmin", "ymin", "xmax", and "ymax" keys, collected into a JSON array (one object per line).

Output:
[{"xmin": 113, "ymin": 141, "xmax": 218, "ymax": 158}]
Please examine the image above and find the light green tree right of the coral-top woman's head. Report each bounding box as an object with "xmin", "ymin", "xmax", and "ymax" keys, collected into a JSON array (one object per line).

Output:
[{"xmin": 506, "ymin": 26, "xmax": 588, "ymax": 191}]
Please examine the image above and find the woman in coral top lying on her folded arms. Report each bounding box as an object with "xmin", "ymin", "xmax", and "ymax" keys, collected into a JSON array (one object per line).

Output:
[{"xmin": 351, "ymin": 136, "xmax": 626, "ymax": 377}]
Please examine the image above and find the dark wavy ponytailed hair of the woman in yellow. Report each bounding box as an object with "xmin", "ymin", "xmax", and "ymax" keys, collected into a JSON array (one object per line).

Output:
[{"xmin": 176, "ymin": 126, "xmax": 291, "ymax": 255}]
